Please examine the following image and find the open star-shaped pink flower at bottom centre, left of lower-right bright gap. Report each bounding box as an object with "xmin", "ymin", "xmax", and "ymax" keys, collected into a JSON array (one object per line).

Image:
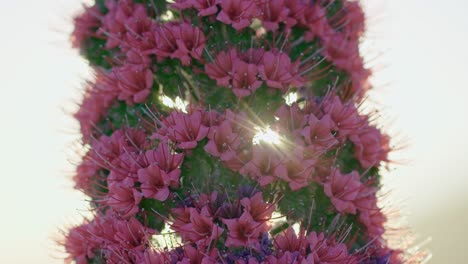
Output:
[{"xmin": 223, "ymin": 211, "xmax": 265, "ymax": 247}]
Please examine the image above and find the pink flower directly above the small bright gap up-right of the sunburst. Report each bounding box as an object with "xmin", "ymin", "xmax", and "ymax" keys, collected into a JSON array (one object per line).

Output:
[{"xmin": 259, "ymin": 51, "xmax": 304, "ymax": 91}]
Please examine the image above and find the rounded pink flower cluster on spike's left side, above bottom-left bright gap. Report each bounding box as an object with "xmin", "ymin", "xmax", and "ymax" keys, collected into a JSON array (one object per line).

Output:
[{"xmin": 74, "ymin": 129, "xmax": 184, "ymax": 211}]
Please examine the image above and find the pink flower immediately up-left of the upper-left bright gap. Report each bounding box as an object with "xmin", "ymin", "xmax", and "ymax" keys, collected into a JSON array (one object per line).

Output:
[{"xmin": 113, "ymin": 66, "xmax": 154, "ymax": 105}]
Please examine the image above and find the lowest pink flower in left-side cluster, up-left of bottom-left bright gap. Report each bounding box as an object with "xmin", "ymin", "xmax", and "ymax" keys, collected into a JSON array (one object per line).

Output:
[{"xmin": 105, "ymin": 179, "xmax": 142, "ymax": 218}]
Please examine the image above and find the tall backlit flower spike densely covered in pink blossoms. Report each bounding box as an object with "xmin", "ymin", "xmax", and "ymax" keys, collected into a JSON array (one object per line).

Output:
[{"xmin": 63, "ymin": 0, "xmax": 426, "ymax": 264}]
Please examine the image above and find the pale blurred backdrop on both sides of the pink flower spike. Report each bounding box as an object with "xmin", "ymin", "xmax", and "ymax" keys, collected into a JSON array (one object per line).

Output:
[{"xmin": 0, "ymin": 0, "xmax": 468, "ymax": 264}]
